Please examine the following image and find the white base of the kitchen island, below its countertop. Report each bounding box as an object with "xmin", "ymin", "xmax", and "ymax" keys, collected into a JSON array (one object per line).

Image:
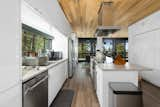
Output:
[{"xmin": 96, "ymin": 65, "xmax": 138, "ymax": 107}]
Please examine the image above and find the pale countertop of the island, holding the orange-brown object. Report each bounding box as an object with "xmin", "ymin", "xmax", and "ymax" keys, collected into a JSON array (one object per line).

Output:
[{"xmin": 97, "ymin": 62, "xmax": 152, "ymax": 71}]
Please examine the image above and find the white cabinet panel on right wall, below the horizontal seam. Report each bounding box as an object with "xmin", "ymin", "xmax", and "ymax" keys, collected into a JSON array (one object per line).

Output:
[{"xmin": 129, "ymin": 29, "xmax": 160, "ymax": 69}]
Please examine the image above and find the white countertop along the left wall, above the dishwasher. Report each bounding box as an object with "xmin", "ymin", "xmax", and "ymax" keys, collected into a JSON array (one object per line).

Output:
[{"xmin": 22, "ymin": 58, "xmax": 68, "ymax": 82}]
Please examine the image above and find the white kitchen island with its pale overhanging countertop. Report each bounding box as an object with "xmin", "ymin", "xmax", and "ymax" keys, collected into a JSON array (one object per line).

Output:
[{"xmin": 95, "ymin": 63, "xmax": 151, "ymax": 107}]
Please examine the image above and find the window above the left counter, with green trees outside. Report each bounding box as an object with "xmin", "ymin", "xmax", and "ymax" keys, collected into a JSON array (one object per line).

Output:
[{"xmin": 22, "ymin": 25, "xmax": 52, "ymax": 56}]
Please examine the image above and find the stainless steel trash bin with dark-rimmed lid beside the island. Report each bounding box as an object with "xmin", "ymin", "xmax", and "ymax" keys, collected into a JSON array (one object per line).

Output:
[{"xmin": 109, "ymin": 82, "xmax": 142, "ymax": 107}]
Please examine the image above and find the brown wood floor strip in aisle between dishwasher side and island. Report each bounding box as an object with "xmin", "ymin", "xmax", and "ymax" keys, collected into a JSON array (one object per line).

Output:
[{"xmin": 63, "ymin": 63, "xmax": 99, "ymax": 107}]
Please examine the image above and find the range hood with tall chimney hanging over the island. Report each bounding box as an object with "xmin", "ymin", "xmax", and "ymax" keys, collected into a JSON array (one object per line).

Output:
[{"xmin": 95, "ymin": 2, "xmax": 121, "ymax": 36}]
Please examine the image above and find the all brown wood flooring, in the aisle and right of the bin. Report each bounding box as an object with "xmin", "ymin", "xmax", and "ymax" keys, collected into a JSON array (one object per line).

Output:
[{"xmin": 63, "ymin": 62, "xmax": 160, "ymax": 107}]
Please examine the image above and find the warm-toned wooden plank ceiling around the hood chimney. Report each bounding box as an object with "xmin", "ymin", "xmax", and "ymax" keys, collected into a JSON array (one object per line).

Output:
[{"xmin": 59, "ymin": 0, "xmax": 160, "ymax": 37}]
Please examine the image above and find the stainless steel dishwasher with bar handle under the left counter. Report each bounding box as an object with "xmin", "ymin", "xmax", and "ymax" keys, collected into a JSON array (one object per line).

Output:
[{"xmin": 23, "ymin": 71, "xmax": 48, "ymax": 107}]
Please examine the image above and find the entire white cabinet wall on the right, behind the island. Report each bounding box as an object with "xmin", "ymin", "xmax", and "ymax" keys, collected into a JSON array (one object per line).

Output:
[{"xmin": 129, "ymin": 11, "xmax": 160, "ymax": 86}]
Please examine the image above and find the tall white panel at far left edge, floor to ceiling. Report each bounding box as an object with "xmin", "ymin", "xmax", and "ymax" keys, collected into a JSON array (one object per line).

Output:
[{"xmin": 0, "ymin": 0, "xmax": 22, "ymax": 107}]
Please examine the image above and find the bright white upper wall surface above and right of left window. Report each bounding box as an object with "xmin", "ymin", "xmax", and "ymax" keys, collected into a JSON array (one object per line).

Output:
[{"xmin": 21, "ymin": 1, "xmax": 69, "ymax": 58}]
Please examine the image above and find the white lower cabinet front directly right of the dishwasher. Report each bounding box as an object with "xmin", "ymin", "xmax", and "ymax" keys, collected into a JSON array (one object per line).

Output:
[{"xmin": 48, "ymin": 60, "xmax": 68, "ymax": 106}]
